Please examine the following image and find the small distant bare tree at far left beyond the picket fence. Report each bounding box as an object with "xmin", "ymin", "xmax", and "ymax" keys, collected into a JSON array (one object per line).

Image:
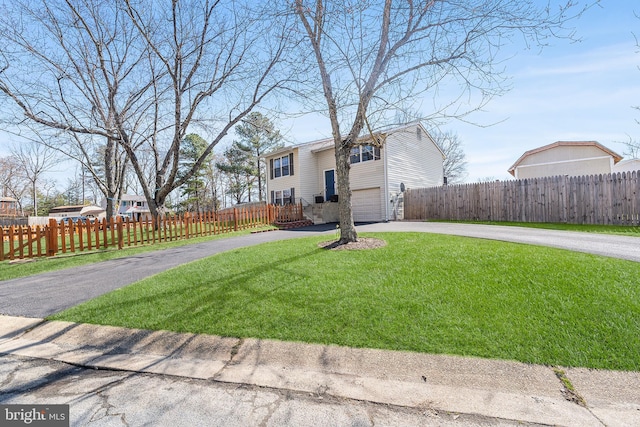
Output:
[{"xmin": 11, "ymin": 142, "xmax": 58, "ymax": 215}]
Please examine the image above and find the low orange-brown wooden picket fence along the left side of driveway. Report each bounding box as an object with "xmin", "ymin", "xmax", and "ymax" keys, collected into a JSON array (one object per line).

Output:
[{"xmin": 0, "ymin": 205, "xmax": 303, "ymax": 261}]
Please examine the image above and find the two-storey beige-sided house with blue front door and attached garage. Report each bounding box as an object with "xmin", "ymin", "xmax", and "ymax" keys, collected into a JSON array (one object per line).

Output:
[{"xmin": 263, "ymin": 123, "xmax": 444, "ymax": 223}]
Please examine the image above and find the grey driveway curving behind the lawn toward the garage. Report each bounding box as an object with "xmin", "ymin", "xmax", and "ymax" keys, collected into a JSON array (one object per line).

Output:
[{"xmin": 0, "ymin": 222, "xmax": 640, "ymax": 318}]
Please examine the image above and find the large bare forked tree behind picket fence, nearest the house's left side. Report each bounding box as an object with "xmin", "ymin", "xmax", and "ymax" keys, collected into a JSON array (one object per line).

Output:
[{"xmin": 119, "ymin": 1, "xmax": 295, "ymax": 219}]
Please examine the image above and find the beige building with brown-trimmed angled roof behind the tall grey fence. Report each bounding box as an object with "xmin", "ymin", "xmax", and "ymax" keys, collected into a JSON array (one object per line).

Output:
[{"xmin": 509, "ymin": 141, "xmax": 622, "ymax": 179}]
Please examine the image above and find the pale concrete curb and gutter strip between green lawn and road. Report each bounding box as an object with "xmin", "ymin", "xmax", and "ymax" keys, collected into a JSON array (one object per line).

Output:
[{"xmin": 0, "ymin": 316, "xmax": 640, "ymax": 426}]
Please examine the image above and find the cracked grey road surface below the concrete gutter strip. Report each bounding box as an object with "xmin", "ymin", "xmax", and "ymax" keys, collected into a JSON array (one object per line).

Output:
[{"xmin": 0, "ymin": 356, "xmax": 522, "ymax": 427}]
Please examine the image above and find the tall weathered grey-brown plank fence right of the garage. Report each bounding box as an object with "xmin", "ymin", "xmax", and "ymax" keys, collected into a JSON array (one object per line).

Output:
[{"xmin": 404, "ymin": 171, "xmax": 640, "ymax": 226}]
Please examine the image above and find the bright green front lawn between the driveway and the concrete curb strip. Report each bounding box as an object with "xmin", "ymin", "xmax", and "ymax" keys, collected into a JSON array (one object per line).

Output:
[{"xmin": 52, "ymin": 233, "xmax": 640, "ymax": 370}]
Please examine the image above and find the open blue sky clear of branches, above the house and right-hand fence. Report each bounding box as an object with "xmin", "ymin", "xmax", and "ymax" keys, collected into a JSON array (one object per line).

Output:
[{"xmin": 282, "ymin": 0, "xmax": 640, "ymax": 182}]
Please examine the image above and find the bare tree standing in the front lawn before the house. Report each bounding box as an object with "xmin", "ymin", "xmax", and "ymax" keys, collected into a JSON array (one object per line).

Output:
[{"xmin": 294, "ymin": 0, "xmax": 592, "ymax": 243}]
